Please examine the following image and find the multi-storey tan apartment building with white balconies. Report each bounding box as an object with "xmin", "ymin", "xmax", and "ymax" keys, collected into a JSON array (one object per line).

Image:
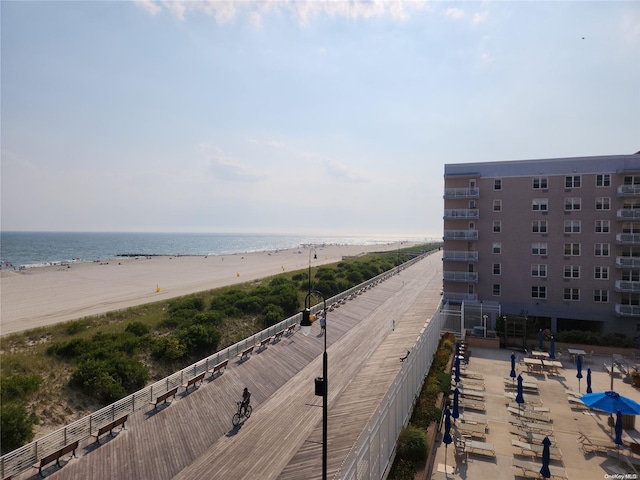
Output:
[{"xmin": 443, "ymin": 152, "xmax": 640, "ymax": 337}]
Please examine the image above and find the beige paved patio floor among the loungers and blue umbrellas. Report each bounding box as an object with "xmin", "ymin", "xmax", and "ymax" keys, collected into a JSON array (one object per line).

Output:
[{"xmin": 431, "ymin": 348, "xmax": 640, "ymax": 480}]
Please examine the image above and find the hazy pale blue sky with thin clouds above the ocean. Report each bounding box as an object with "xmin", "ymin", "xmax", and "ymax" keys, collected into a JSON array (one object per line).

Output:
[{"xmin": 0, "ymin": 0, "xmax": 640, "ymax": 237}]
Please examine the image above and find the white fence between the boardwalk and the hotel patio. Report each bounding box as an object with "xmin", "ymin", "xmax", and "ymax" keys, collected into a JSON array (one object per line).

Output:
[{"xmin": 334, "ymin": 298, "xmax": 447, "ymax": 480}]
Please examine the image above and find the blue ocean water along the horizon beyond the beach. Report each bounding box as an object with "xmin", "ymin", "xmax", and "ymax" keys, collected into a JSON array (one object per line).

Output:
[{"xmin": 0, "ymin": 232, "xmax": 426, "ymax": 268}]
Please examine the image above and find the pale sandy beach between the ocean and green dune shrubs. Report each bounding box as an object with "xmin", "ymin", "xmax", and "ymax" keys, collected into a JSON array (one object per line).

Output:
[{"xmin": 0, "ymin": 242, "xmax": 409, "ymax": 335}]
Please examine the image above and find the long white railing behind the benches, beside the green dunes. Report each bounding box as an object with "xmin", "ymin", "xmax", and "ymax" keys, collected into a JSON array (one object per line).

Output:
[{"xmin": 0, "ymin": 252, "xmax": 433, "ymax": 478}]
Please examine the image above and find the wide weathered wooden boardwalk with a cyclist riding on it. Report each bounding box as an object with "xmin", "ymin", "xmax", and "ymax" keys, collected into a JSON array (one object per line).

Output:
[{"xmin": 35, "ymin": 253, "xmax": 442, "ymax": 480}]
